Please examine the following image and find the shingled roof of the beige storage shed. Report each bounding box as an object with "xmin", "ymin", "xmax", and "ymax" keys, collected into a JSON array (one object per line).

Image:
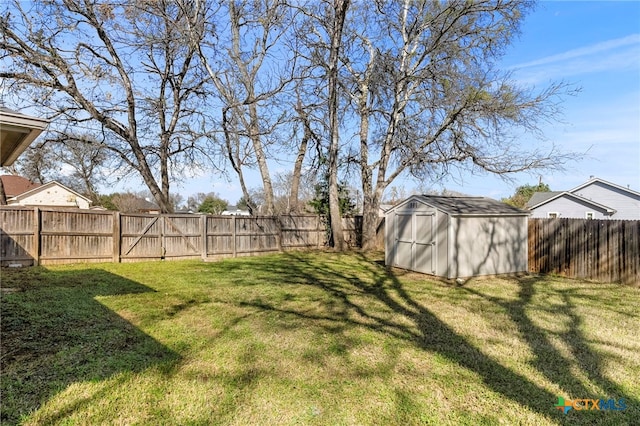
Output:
[{"xmin": 389, "ymin": 195, "xmax": 529, "ymax": 216}]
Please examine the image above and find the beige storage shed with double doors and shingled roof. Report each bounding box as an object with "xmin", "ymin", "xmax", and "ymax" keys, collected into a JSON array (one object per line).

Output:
[{"xmin": 385, "ymin": 195, "xmax": 529, "ymax": 278}]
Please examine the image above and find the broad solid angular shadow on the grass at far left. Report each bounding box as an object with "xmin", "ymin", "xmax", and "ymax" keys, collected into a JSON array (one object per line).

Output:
[{"xmin": 0, "ymin": 268, "xmax": 179, "ymax": 425}]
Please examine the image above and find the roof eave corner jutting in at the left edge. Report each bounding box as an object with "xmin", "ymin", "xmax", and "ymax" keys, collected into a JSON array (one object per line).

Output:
[{"xmin": 0, "ymin": 107, "xmax": 49, "ymax": 167}]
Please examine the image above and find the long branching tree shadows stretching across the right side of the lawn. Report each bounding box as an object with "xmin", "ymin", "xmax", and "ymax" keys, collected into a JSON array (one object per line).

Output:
[{"xmin": 238, "ymin": 252, "xmax": 640, "ymax": 424}]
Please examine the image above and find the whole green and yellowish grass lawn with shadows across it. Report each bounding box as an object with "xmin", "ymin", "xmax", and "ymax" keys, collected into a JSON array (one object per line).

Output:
[{"xmin": 1, "ymin": 252, "xmax": 640, "ymax": 425}]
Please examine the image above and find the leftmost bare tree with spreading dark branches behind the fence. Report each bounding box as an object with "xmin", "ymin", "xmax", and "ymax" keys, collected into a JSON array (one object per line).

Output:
[{"xmin": 0, "ymin": 0, "xmax": 207, "ymax": 212}]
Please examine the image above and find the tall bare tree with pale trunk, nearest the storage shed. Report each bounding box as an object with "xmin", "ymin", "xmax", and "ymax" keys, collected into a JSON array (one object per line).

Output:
[{"xmin": 340, "ymin": 0, "xmax": 567, "ymax": 249}]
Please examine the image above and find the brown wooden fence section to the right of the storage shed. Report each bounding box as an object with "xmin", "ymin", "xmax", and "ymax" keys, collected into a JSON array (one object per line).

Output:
[{"xmin": 529, "ymin": 218, "xmax": 640, "ymax": 285}]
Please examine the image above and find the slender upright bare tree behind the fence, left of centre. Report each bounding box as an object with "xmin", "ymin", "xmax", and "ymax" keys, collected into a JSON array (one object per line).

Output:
[{"xmin": 181, "ymin": 0, "xmax": 295, "ymax": 214}]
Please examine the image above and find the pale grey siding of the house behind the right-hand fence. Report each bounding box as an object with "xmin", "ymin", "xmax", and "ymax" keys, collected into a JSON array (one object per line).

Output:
[{"xmin": 565, "ymin": 182, "xmax": 640, "ymax": 220}]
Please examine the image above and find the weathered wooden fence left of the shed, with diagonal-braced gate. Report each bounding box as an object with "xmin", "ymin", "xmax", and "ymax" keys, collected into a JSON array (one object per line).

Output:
[{"xmin": 0, "ymin": 207, "xmax": 362, "ymax": 266}]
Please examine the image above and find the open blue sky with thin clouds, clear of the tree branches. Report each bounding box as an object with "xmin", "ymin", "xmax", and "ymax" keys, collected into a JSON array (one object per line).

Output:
[{"xmin": 176, "ymin": 1, "xmax": 640, "ymax": 203}]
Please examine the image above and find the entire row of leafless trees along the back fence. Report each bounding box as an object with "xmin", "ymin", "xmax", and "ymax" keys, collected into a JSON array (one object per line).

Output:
[{"xmin": 0, "ymin": 0, "xmax": 570, "ymax": 248}]
